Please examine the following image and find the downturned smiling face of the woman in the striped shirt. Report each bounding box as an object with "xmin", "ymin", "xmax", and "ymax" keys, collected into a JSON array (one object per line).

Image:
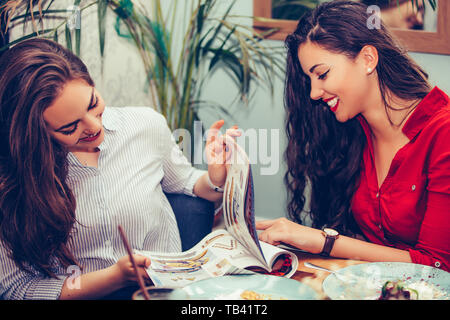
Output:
[{"xmin": 44, "ymin": 80, "xmax": 105, "ymax": 151}]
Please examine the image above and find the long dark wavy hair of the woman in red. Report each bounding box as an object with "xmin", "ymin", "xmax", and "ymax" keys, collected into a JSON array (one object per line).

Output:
[{"xmin": 284, "ymin": 1, "xmax": 431, "ymax": 234}]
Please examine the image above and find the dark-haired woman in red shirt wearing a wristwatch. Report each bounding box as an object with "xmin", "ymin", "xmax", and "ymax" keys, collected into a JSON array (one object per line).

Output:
[{"xmin": 257, "ymin": 1, "xmax": 450, "ymax": 271}]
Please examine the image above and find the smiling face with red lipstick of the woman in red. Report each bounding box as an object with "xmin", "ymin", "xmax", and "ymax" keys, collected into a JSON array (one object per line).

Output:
[{"xmin": 298, "ymin": 41, "xmax": 373, "ymax": 122}]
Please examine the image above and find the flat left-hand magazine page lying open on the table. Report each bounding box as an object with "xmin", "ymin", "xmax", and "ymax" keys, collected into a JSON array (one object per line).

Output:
[{"xmin": 135, "ymin": 230, "xmax": 265, "ymax": 287}]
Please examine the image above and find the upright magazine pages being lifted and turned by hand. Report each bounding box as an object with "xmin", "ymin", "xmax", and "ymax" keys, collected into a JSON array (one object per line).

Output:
[{"xmin": 223, "ymin": 143, "xmax": 270, "ymax": 269}]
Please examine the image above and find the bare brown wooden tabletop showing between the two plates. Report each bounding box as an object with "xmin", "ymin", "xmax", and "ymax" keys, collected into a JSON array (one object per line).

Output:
[{"xmin": 292, "ymin": 251, "xmax": 367, "ymax": 299}]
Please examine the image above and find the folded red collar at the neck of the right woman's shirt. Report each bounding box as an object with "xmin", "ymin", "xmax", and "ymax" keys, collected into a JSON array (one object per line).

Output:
[{"xmin": 402, "ymin": 87, "xmax": 449, "ymax": 140}]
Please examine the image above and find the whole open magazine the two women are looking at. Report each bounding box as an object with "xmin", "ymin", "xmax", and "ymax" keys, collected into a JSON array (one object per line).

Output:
[{"xmin": 135, "ymin": 143, "xmax": 298, "ymax": 287}]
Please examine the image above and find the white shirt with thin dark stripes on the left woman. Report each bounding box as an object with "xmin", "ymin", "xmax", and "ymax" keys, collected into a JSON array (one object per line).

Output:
[{"xmin": 0, "ymin": 107, "xmax": 205, "ymax": 299}]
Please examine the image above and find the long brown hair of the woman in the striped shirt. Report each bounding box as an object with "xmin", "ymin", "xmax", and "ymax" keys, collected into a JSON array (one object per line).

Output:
[{"xmin": 0, "ymin": 39, "xmax": 94, "ymax": 277}]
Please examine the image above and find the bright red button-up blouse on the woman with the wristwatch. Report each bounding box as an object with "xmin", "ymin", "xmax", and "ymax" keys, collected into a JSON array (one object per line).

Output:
[{"xmin": 352, "ymin": 87, "xmax": 450, "ymax": 271}]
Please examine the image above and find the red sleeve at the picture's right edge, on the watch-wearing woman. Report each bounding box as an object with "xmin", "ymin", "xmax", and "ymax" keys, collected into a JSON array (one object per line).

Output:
[{"xmin": 409, "ymin": 118, "xmax": 450, "ymax": 272}]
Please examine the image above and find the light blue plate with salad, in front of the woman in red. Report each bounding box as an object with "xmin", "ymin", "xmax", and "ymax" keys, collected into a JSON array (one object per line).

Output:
[{"xmin": 322, "ymin": 262, "xmax": 450, "ymax": 300}]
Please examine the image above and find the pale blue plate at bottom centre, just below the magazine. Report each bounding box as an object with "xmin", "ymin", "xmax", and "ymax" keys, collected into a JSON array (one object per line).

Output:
[{"xmin": 179, "ymin": 275, "xmax": 321, "ymax": 300}]
